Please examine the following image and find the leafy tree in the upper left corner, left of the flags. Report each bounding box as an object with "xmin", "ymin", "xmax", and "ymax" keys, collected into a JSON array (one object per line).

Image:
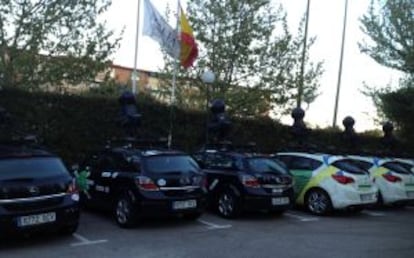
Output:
[{"xmin": 0, "ymin": 0, "xmax": 119, "ymax": 88}]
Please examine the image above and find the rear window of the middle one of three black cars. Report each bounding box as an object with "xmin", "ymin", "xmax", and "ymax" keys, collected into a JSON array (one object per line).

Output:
[{"xmin": 145, "ymin": 155, "xmax": 199, "ymax": 174}]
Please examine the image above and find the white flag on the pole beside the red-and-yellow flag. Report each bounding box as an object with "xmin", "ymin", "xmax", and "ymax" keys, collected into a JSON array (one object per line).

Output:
[{"xmin": 143, "ymin": 0, "xmax": 180, "ymax": 58}]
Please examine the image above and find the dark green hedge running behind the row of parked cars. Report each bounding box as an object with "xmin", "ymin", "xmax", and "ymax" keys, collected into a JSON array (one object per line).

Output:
[{"xmin": 0, "ymin": 89, "xmax": 414, "ymax": 163}]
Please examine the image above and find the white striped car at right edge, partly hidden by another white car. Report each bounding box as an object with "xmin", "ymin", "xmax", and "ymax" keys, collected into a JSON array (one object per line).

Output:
[{"xmin": 350, "ymin": 156, "xmax": 414, "ymax": 206}]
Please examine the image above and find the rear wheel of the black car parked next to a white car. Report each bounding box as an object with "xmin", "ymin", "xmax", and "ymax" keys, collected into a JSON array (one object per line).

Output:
[{"xmin": 217, "ymin": 188, "xmax": 241, "ymax": 219}]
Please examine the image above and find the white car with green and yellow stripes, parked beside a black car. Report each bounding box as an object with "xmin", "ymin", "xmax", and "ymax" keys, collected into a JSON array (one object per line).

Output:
[{"xmin": 275, "ymin": 152, "xmax": 378, "ymax": 215}]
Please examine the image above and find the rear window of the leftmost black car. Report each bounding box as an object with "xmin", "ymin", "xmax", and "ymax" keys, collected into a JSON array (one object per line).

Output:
[{"xmin": 0, "ymin": 157, "xmax": 68, "ymax": 180}]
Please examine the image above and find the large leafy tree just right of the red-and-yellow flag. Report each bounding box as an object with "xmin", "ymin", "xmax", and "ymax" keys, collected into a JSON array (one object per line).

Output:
[{"xmin": 158, "ymin": 0, "xmax": 322, "ymax": 116}]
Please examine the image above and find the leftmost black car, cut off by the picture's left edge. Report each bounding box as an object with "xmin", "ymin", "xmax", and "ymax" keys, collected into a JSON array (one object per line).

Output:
[{"xmin": 0, "ymin": 145, "xmax": 79, "ymax": 237}]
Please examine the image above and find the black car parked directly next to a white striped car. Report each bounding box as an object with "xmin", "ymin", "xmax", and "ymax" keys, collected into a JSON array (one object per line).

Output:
[{"xmin": 193, "ymin": 150, "xmax": 294, "ymax": 218}]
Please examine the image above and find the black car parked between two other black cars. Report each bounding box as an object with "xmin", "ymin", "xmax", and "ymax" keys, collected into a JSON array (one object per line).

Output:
[{"xmin": 81, "ymin": 147, "xmax": 207, "ymax": 227}]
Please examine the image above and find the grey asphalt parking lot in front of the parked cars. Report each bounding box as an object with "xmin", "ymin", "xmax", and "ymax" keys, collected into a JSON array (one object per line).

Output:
[{"xmin": 0, "ymin": 206, "xmax": 414, "ymax": 258}]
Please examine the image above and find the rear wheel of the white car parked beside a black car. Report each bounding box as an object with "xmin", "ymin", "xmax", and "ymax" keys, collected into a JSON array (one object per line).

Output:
[{"xmin": 306, "ymin": 189, "xmax": 332, "ymax": 215}]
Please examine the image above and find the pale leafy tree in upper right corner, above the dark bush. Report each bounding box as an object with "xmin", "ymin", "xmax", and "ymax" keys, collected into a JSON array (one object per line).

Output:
[{"xmin": 359, "ymin": 0, "xmax": 414, "ymax": 74}]
